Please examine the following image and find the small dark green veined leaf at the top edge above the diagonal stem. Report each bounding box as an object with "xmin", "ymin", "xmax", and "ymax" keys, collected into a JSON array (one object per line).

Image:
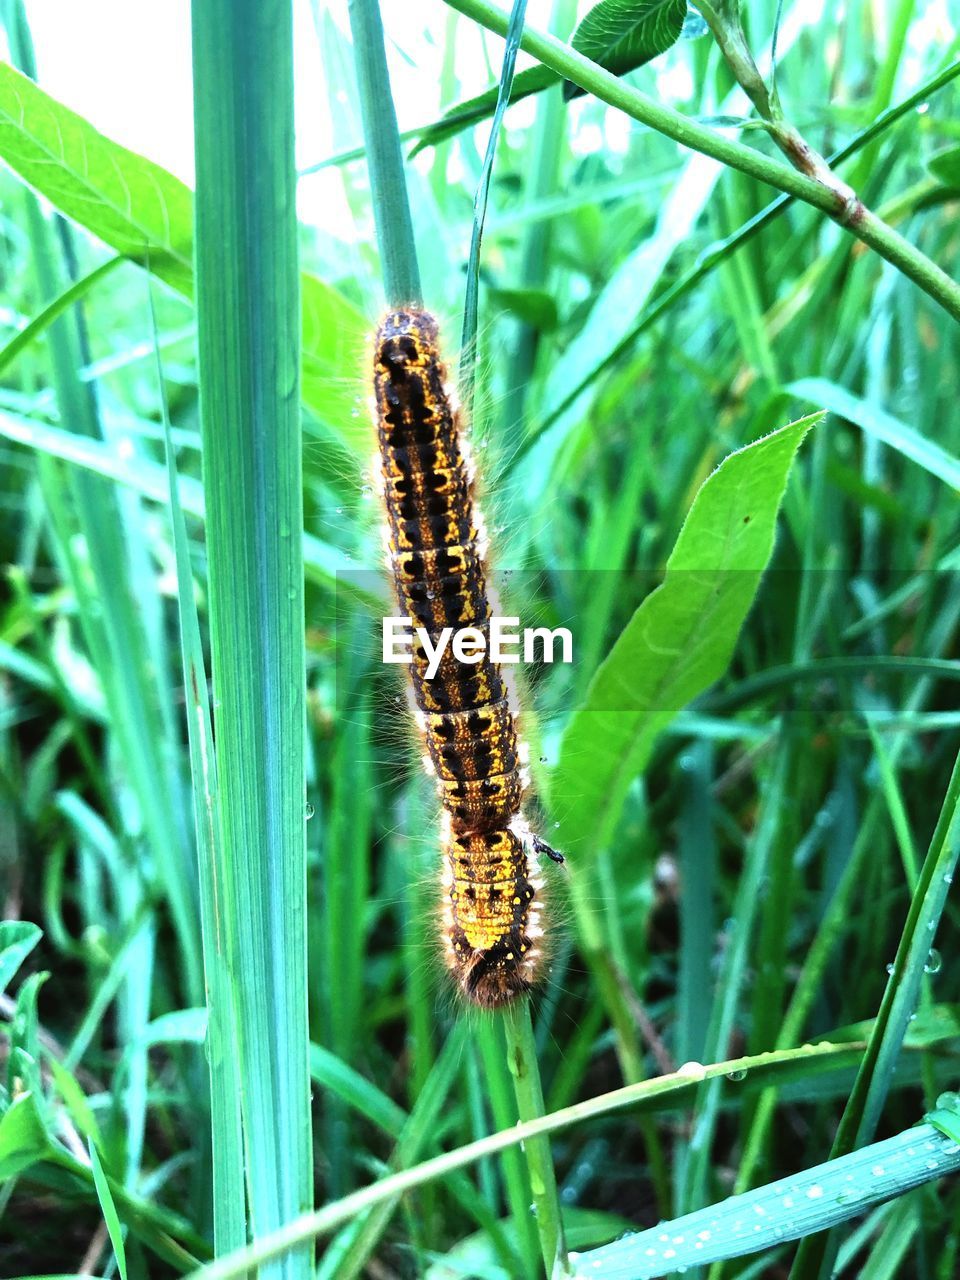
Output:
[{"xmin": 563, "ymin": 0, "xmax": 686, "ymax": 100}]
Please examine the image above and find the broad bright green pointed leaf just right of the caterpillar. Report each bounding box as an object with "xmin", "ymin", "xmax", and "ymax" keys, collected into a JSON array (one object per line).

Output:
[{"xmin": 550, "ymin": 413, "xmax": 820, "ymax": 858}]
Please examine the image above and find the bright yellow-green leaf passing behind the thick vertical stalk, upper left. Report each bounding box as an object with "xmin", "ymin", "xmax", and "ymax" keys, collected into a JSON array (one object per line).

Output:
[{"xmin": 0, "ymin": 63, "xmax": 369, "ymax": 463}]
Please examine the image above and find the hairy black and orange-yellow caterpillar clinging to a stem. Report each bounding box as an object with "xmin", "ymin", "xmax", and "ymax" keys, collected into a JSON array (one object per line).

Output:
[{"xmin": 374, "ymin": 307, "xmax": 563, "ymax": 1009}]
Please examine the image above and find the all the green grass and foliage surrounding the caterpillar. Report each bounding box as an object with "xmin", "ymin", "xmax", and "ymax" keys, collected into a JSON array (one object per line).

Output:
[{"xmin": 0, "ymin": 0, "xmax": 960, "ymax": 1280}]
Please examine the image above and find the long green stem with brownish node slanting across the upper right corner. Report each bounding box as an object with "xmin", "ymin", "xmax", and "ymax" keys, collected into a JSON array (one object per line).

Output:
[{"xmin": 445, "ymin": 0, "xmax": 960, "ymax": 320}]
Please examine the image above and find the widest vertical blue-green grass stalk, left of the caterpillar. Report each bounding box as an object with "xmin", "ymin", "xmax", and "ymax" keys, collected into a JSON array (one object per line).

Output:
[{"xmin": 186, "ymin": 0, "xmax": 312, "ymax": 1280}]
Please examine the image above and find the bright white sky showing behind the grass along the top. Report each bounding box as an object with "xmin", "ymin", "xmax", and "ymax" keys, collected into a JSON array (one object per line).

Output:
[{"xmin": 0, "ymin": 0, "xmax": 955, "ymax": 241}]
